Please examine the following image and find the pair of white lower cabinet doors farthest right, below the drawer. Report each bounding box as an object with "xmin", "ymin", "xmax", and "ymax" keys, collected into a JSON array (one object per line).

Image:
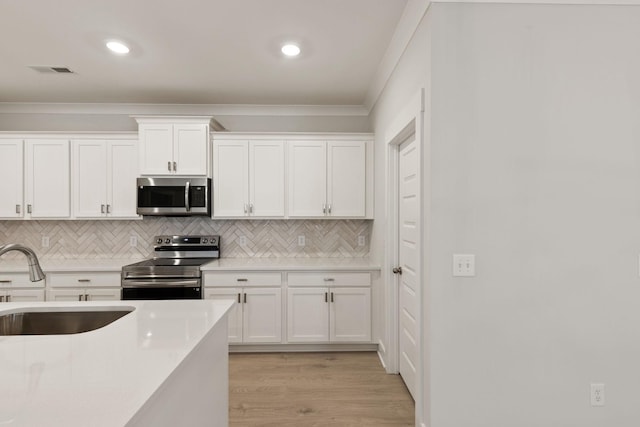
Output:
[{"xmin": 287, "ymin": 287, "xmax": 371, "ymax": 343}]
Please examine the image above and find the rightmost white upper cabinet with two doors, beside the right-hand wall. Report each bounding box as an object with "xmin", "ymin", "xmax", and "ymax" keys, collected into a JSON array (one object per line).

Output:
[{"xmin": 288, "ymin": 140, "xmax": 367, "ymax": 218}]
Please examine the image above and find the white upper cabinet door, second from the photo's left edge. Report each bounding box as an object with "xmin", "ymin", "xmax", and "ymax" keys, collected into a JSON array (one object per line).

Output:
[{"xmin": 25, "ymin": 139, "xmax": 71, "ymax": 218}]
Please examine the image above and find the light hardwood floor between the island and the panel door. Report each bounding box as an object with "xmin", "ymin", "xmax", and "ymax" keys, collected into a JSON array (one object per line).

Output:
[{"xmin": 229, "ymin": 352, "xmax": 414, "ymax": 427}]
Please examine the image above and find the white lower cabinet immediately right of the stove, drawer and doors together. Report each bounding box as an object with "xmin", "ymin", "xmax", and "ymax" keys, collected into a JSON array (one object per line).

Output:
[{"xmin": 204, "ymin": 272, "xmax": 282, "ymax": 344}]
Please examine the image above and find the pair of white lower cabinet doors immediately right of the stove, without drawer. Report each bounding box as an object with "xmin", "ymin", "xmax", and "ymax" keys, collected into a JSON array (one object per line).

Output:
[{"xmin": 204, "ymin": 287, "xmax": 282, "ymax": 343}]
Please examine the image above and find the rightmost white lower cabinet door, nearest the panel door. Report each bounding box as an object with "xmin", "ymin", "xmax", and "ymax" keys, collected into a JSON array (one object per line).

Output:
[{"xmin": 329, "ymin": 288, "xmax": 371, "ymax": 342}]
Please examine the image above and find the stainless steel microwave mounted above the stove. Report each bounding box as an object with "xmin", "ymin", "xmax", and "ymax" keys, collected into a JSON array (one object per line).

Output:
[{"xmin": 137, "ymin": 178, "xmax": 211, "ymax": 216}]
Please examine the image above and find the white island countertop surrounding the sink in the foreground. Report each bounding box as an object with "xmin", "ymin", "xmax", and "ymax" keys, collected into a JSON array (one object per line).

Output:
[{"xmin": 0, "ymin": 300, "xmax": 234, "ymax": 427}]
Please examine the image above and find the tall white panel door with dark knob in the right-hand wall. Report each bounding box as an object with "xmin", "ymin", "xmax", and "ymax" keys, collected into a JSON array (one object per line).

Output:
[{"xmin": 398, "ymin": 139, "xmax": 420, "ymax": 396}]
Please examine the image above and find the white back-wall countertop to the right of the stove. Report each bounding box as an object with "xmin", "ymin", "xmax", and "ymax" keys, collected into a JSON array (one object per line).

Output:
[{"xmin": 201, "ymin": 258, "xmax": 380, "ymax": 271}]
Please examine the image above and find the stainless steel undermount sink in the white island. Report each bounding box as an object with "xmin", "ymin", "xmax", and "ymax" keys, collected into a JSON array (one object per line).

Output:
[{"xmin": 0, "ymin": 307, "xmax": 134, "ymax": 336}]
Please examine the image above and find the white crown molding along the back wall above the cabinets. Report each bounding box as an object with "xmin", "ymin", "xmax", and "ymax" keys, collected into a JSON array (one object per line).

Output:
[{"xmin": 0, "ymin": 102, "xmax": 369, "ymax": 116}]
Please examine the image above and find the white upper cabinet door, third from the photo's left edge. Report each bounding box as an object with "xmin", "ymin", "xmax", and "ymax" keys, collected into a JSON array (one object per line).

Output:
[{"xmin": 72, "ymin": 140, "xmax": 107, "ymax": 218}]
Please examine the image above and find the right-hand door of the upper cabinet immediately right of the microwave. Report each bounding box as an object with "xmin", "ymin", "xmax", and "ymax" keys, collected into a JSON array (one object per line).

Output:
[{"xmin": 249, "ymin": 141, "xmax": 285, "ymax": 217}]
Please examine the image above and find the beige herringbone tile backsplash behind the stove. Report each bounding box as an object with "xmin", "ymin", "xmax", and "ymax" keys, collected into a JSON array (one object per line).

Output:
[{"xmin": 0, "ymin": 217, "xmax": 372, "ymax": 259}]
